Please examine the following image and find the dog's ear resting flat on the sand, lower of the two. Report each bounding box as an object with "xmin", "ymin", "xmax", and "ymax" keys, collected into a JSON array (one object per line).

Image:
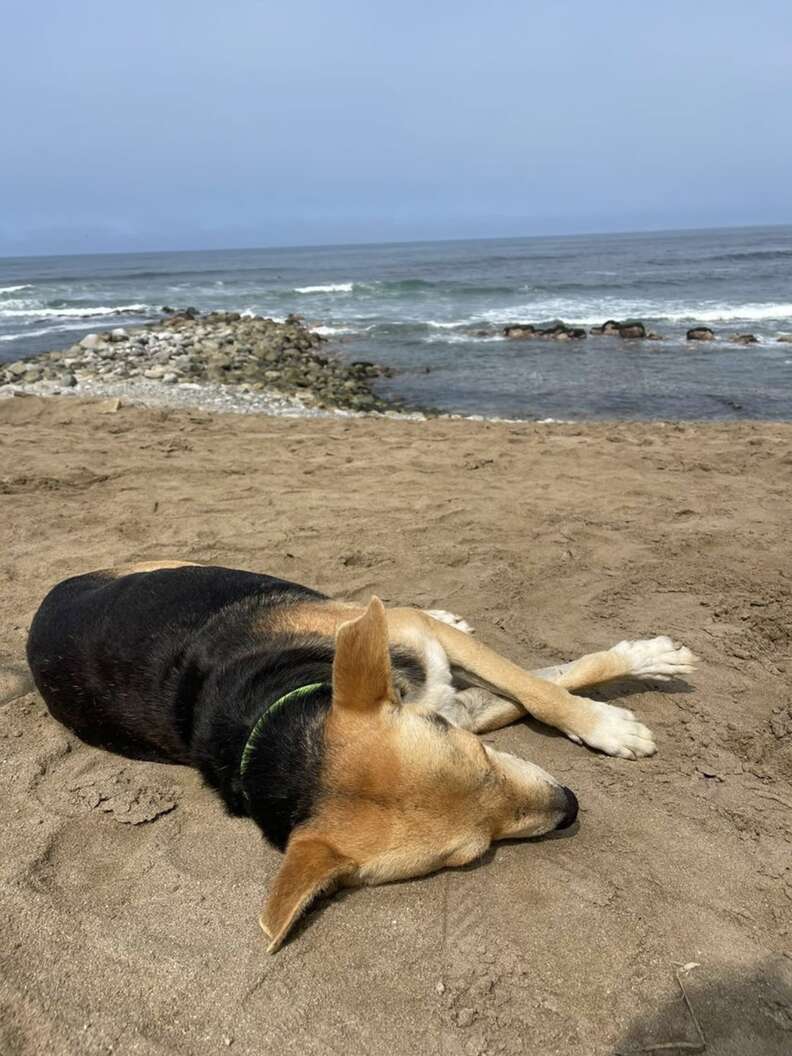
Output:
[{"xmin": 259, "ymin": 833, "xmax": 356, "ymax": 954}]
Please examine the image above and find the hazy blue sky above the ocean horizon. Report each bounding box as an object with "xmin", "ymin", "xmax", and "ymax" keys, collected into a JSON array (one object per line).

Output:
[{"xmin": 0, "ymin": 0, "xmax": 792, "ymax": 256}]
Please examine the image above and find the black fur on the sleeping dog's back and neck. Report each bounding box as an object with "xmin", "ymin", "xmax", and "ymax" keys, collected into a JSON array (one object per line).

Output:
[{"xmin": 27, "ymin": 565, "xmax": 425, "ymax": 849}]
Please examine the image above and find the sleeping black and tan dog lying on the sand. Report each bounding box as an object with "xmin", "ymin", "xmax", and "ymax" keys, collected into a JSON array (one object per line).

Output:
[{"xmin": 27, "ymin": 562, "xmax": 696, "ymax": 950}]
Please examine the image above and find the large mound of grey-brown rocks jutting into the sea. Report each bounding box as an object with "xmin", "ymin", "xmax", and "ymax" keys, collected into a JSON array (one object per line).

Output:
[{"xmin": 0, "ymin": 308, "xmax": 394, "ymax": 411}]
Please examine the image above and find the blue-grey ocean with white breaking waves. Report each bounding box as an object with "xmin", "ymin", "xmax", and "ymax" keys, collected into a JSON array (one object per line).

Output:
[{"xmin": 0, "ymin": 227, "xmax": 792, "ymax": 419}]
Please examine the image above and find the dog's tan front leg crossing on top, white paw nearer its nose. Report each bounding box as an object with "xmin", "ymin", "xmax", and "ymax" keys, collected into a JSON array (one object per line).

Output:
[{"xmin": 388, "ymin": 608, "xmax": 656, "ymax": 759}]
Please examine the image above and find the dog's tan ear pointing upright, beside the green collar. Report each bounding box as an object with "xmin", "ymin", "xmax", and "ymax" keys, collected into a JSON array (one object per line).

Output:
[{"xmin": 333, "ymin": 597, "xmax": 393, "ymax": 712}]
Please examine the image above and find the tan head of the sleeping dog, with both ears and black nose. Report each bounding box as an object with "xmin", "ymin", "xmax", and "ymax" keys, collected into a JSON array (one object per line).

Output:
[{"xmin": 261, "ymin": 598, "xmax": 577, "ymax": 951}]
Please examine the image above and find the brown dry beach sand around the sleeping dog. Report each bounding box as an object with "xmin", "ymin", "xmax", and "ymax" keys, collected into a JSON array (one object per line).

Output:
[{"xmin": 0, "ymin": 397, "xmax": 792, "ymax": 1056}]
